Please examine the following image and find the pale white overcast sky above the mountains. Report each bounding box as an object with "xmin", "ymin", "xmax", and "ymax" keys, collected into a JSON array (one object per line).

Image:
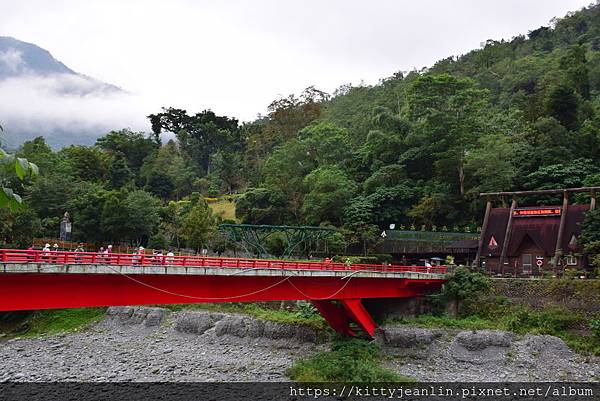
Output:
[{"xmin": 0, "ymin": 0, "xmax": 590, "ymax": 126}]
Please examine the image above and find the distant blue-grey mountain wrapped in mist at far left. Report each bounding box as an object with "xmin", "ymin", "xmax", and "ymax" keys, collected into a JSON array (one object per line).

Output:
[{"xmin": 0, "ymin": 36, "xmax": 125, "ymax": 148}]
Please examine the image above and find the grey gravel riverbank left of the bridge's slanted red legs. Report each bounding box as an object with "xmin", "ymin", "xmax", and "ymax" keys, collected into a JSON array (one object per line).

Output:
[{"xmin": 0, "ymin": 308, "xmax": 324, "ymax": 382}]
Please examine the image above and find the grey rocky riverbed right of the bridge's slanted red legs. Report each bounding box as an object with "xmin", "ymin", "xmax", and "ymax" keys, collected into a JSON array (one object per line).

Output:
[{"xmin": 378, "ymin": 326, "xmax": 600, "ymax": 382}]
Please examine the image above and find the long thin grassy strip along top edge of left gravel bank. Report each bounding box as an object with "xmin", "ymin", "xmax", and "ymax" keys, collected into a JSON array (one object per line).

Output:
[{"xmin": 161, "ymin": 302, "xmax": 329, "ymax": 330}]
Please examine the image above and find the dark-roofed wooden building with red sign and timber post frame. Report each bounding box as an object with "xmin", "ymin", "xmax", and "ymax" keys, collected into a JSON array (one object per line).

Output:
[{"xmin": 474, "ymin": 187, "xmax": 600, "ymax": 276}]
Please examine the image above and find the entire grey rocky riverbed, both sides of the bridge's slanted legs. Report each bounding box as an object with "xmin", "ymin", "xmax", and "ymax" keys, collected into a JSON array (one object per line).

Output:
[{"xmin": 0, "ymin": 307, "xmax": 600, "ymax": 381}]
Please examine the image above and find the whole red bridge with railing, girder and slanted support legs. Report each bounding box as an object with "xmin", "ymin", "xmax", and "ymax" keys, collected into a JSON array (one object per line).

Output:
[{"xmin": 0, "ymin": 249, "xmax": 447, "ymax": 336}]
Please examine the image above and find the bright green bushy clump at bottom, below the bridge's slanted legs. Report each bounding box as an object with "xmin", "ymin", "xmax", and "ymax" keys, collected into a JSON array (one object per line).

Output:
[{"xmin": 287, "ymin": 338, "xmax": 414, "ymax": 383}]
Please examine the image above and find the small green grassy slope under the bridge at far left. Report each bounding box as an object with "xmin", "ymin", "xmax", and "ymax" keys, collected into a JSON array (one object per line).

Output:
[{"xmin": 20, "ymin": 308, "xmax": 106, "ymax": 337}]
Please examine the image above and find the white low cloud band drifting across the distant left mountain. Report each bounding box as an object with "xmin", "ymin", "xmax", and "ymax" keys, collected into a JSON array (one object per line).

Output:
[{"xmin": 0, "ymin": 72, "xmax": 159, "ymax": 148}]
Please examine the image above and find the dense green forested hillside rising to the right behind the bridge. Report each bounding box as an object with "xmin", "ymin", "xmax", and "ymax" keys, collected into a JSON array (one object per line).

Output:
[{"xmin": 5, "ymin": 5, "xmax": 600, "ymax": 256}]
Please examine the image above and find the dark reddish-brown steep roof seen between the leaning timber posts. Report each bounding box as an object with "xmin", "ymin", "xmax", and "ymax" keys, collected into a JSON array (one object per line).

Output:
[{"xmin": 482, "ymin": 205, "xmax": 589, "ymax": 256}]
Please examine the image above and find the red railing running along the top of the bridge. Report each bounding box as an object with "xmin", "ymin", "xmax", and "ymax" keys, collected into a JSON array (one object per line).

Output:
[{"xmin": 0, "ymin": 249, "xmax": 448, "ymax": 274}]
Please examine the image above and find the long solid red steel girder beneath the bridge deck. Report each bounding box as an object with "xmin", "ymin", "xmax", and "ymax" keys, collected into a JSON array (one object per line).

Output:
[{"xmin": 0, "ymin": 273, "xmax": 443, "ymax": 311}]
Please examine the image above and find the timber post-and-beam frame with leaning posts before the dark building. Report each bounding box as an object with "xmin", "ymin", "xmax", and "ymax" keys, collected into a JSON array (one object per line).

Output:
[{"xmin": 473, "ymin": 187, "xmax": 600, "ymax": 268}]
